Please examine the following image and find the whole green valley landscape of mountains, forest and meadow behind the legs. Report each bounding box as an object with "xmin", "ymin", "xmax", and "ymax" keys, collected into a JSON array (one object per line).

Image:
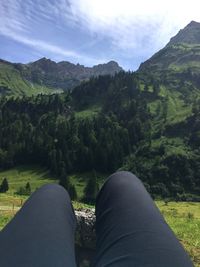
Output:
[{"xmin": 0, "ymin": 21, "xmax": 200, "ymax": 267}]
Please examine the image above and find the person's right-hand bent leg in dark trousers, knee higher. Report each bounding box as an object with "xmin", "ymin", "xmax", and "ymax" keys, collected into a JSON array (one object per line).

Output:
[{"xmin": 94, "ymin": 172, "xmax": 193, "ymax": 267}]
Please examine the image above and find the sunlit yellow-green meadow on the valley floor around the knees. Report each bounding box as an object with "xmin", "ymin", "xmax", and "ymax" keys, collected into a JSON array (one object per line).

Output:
[{"xmin": 0, "ymin": 166, "xmax": 200, "ymax": 267}]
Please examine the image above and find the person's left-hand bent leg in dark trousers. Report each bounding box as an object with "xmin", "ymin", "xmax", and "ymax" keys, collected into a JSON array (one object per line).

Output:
[{"xmin": 0, "ymin": 184, "xmax": 76, "ymax": 267}]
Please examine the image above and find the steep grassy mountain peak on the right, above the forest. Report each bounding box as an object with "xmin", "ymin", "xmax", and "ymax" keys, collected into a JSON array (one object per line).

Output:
[{"xmin": 137, "ymin": 21, "xmax": 200, "ymax": 133}]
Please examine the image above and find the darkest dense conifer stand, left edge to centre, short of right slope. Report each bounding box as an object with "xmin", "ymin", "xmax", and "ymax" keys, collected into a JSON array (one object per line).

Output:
[{"xmin": 0, "ymin": 73, "xmax": 148, "ymax": 177}]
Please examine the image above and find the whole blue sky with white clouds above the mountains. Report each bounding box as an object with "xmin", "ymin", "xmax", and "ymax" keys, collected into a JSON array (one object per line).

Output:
[{"xmin": 0, "ymin": 0, "xmax": 200, "ymax": 70}]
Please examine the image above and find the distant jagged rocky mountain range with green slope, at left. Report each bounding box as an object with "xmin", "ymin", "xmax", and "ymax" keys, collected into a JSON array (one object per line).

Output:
[{"xmin": 0, "ymin": 58, "xmax": 123, "ymax": 95}]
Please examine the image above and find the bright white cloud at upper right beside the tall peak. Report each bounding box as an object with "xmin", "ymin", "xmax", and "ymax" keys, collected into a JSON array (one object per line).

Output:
[{"xmin": 69, "ymin": 0, "xmax": 200, "ymax": 53}]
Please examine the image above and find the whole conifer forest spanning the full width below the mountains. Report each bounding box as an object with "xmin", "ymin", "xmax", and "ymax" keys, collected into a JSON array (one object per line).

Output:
[{"xmin": 0, "ymin": 72, "xmax": 200, "ymax": 201}]
